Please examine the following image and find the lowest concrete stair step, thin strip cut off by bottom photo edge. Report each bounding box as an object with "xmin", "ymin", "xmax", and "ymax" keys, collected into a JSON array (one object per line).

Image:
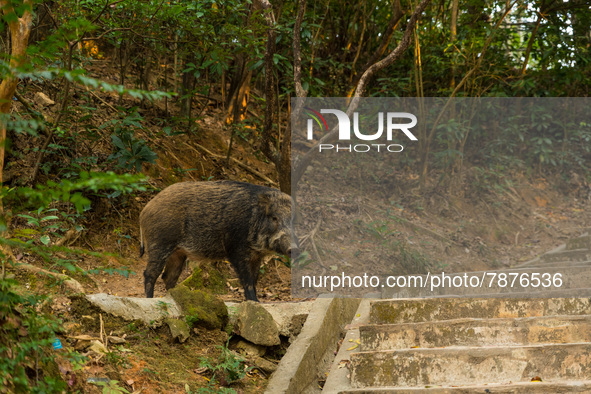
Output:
[{"xmin": 341, "ymin": 380, "xmax": 591, "ymax": 394}]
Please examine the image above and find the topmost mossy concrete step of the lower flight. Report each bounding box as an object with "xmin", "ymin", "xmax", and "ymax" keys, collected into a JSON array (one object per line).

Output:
[{"xmin": 369, "ymin": 298, "xmax": 591, "ymax": 324}]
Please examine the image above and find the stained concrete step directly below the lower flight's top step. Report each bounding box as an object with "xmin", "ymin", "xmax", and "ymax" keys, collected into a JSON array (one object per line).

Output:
[{"xmin": 359, "ymin": 315, "xmax": 591, "ymax": 352}]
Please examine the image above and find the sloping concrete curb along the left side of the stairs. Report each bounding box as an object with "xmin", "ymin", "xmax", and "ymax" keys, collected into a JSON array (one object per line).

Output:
[{"xmin": 265, "ymin": 297, "xmax": 361, "ymax": 394}]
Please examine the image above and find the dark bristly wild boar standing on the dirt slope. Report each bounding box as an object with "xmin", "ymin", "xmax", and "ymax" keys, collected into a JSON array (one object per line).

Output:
[{"xmin": 140, "ymin": 181, "xmax": 298, "ymax": 301}]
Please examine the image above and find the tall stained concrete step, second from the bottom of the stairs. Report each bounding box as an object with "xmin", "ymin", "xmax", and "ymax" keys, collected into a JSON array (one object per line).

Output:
[{"xmin": 351, "ymin": 342, "xmax": 591, "ymax": 388}]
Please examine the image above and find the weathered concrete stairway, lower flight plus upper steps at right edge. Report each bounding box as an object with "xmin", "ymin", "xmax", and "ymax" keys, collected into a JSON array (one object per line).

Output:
[{"xmin": 323, "ymin": 234, "xmax": 591, "ymax": 394}]
